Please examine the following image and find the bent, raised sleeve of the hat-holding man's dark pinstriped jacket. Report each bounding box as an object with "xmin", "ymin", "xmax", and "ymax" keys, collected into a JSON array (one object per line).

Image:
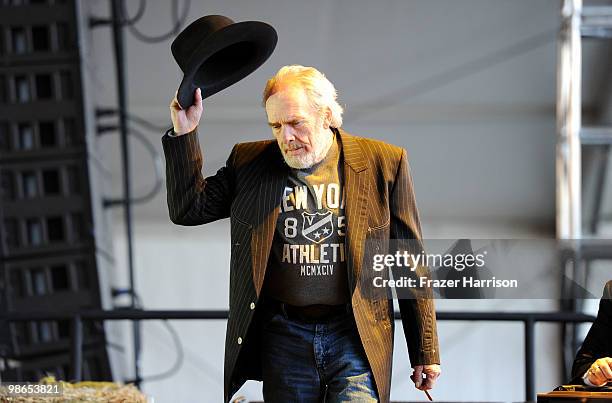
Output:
[{"xmin": 162, "ymin": 128, "xmax": 236, "ymax": 225}]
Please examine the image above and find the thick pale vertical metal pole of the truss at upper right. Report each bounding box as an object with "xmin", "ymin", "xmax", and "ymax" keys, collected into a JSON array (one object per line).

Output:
[{"xmin": 556, "ymin": 0, "xmax": 582, "ymax": 240}]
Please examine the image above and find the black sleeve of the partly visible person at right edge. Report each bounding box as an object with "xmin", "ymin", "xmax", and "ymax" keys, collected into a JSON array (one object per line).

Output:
[{"xmin": 571, "ymin": 281, "xmax": 612, "ymax": 385}]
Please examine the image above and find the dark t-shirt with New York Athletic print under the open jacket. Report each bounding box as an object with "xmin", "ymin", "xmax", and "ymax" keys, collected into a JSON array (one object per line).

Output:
[{"xmin": 264, "ymin": 138, "xmax": 349, "ymax": 306}]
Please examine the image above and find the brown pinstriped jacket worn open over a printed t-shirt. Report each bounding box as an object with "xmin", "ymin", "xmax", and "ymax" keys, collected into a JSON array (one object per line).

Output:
[{"xmin": 162, "ymin": 129, "xmax": 440, "ymax": 403}]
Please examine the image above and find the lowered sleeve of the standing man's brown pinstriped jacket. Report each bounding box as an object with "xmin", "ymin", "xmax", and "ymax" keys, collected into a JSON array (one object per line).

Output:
[{"xmin": 390, "ymin": 150, "xmax": 440, "ymax": 366}]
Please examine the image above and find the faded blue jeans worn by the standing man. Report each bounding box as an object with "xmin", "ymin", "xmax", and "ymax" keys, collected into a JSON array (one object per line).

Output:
[{"xmin": 261, "ymin": 313, "xmax": 378, "ymax": 403}]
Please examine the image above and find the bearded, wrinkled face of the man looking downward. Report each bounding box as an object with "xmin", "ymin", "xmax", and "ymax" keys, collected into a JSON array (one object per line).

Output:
[{"xmin": 266, "ymin": 86, "xmax": 333, "ymax": 169}]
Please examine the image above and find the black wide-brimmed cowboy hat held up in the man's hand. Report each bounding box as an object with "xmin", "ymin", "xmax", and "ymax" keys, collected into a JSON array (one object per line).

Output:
[{"xmin": 171, "ymin": 15, "xmax": 277, "ymax": 109}]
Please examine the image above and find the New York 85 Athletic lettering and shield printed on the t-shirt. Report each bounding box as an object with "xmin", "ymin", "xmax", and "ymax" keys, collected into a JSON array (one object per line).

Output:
[{"xmin": 278, "ymin": 183, "xmax": 345, "ymax": 276}]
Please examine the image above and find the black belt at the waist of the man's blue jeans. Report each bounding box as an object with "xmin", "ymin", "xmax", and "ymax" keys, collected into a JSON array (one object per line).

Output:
[{"xmin": 265, "ymin": 298, "xmax": 352, "ymax": 323}]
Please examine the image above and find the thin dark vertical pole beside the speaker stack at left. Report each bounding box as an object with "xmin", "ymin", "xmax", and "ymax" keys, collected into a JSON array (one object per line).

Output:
[{"xmin": 111, "ymin": 0, "xmax": 141, "ymax": 387}]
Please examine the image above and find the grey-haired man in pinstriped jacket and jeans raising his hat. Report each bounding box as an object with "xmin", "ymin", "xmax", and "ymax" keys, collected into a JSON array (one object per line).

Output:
[{"xmin": 162, "ymin": 66, "xmax": 440, "ymax": 403}]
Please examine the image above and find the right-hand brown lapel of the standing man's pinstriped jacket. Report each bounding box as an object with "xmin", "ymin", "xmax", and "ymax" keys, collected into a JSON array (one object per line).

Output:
[{"xmin": 338, "ymin": 129, "xmax": 370, "ymax": 294}]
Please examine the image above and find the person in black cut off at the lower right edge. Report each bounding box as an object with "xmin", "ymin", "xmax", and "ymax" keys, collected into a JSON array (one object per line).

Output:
[{"xmin": 572, "ymin": 280, "xmax": 612, "ymax": 386}]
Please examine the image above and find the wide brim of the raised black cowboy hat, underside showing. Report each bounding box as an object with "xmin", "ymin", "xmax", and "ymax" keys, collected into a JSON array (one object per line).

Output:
[{"xmin": 177, "ymin": 21, "xmax": 278, "ymax": 109}]
